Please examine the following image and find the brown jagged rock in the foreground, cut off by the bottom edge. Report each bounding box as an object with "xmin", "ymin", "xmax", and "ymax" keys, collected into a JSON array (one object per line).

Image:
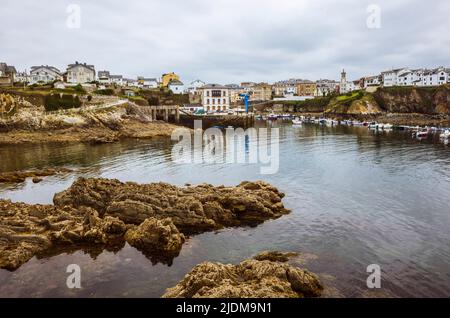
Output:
[{"xmin": 163, "ymin": 252, "xmax": 323, "ymax": 298}]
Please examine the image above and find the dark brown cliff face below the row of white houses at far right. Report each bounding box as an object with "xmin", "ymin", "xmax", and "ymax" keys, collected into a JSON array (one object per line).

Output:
[{"xmin": 373, "ymin": 85, "xmax": 450, "ymax": 115}]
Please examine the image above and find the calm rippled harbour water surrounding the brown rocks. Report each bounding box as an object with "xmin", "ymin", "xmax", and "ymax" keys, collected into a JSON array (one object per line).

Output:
[{"xmin": 0, "ymin": 124, "xmax": 450, "ymax": 297}]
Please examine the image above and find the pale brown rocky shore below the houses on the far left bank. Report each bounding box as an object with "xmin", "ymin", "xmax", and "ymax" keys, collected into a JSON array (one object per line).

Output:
[{"xmin": 0, "ymin": 103, "xmax": 178, "ymax": 145}]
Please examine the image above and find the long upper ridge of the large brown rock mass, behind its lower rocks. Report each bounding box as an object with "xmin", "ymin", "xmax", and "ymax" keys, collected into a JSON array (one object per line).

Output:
[{"xmin": 53, "ymin": 178, "xmax": 289, "ymax": 234}]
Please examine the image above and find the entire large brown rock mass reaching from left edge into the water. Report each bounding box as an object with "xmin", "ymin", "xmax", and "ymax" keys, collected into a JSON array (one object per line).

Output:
[{"xmin": 0, "ymin": 178, "xmax": 289, "ymax": 270}]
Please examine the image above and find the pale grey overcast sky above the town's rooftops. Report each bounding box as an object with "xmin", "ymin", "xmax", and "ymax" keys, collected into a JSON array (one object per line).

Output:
[{"xmin": 0, "ymin": 0, "xmax": 450, "ymax": 84}]
